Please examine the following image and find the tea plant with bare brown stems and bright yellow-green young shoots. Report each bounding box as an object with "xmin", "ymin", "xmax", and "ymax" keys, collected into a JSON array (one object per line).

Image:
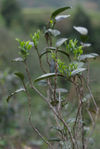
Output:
[{"xmin": 7, "ymin": 7, "xmax": 98, "ymax": 149}]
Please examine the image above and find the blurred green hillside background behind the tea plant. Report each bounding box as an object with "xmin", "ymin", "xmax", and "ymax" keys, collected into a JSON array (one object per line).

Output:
[{"xmin": 0, "ymin": 0, "xmax": 100, "ymax": 149}]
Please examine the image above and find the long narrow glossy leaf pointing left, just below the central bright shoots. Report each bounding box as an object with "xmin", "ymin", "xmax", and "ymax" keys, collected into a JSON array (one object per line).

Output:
[{"xmin": 34, "ymin": 73, "xmax": 63, "ymax": 82}]
